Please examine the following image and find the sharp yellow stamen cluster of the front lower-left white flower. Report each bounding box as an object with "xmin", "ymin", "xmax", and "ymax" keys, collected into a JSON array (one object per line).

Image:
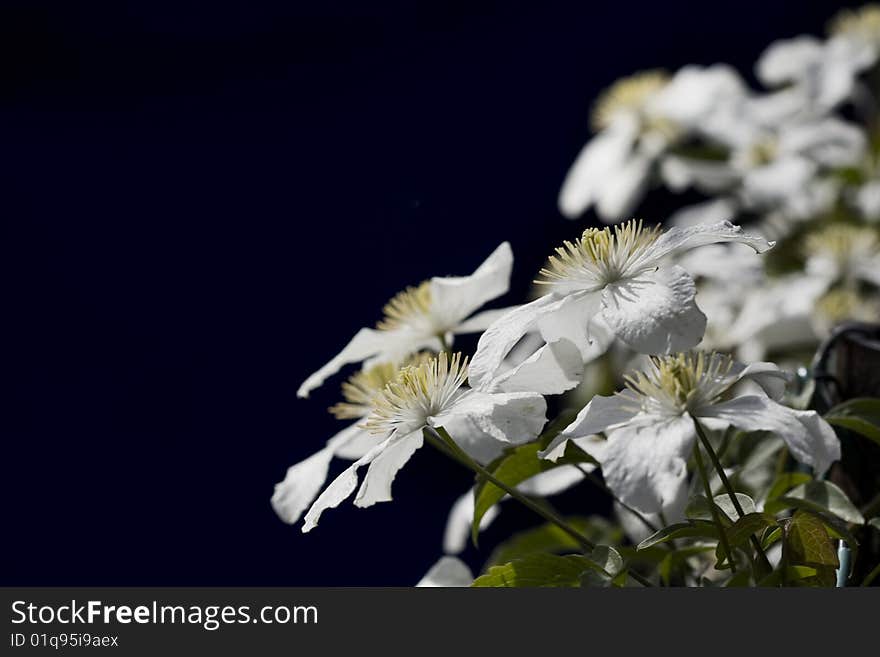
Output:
[{"xmin": 363, "ymin": 352, "xmax": 467, "ymax": 434}]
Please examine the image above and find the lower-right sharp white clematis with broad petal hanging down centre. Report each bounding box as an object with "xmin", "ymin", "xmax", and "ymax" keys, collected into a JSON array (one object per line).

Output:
[{"xmin": 542, "ymin": 352, "xmax": 840, "ymax": 513}]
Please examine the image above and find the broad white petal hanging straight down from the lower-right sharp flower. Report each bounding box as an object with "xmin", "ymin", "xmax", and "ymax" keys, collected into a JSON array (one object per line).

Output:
[{"xmin": 601, "ymin": 415, "xmax": 696, "ymax": 513}]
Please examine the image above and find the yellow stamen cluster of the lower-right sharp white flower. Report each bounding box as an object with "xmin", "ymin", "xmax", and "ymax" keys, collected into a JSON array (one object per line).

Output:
[{"xmin": 624, "ymin": 351, "xmax": 733, "ymax": 412}]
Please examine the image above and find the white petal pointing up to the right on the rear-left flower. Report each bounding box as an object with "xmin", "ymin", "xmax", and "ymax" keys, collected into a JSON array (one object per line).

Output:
[{"xmin": 431, "ymin": 242, "xmax": 513, "ymax": 327}]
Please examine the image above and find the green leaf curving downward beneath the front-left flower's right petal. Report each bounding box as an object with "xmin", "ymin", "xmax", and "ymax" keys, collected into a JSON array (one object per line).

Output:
[{"xmin": 471, "ymin": 416, "xmax": 596, "ymax": 545}]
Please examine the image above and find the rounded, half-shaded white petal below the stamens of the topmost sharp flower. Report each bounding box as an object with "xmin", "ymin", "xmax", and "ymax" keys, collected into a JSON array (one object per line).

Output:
[{"xmin": 602, "ymin": 266, "xmax": 706, "ymax": 354}]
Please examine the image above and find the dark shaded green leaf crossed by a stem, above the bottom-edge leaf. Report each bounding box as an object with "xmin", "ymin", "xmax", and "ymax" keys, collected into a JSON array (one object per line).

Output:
[{"xmin": 487, "ymin": 516, "xmax": 623, "ymax": 566}]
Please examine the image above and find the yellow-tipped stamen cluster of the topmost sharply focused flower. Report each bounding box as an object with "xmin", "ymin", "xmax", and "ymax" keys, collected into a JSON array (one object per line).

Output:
[{"xmin": 535, "ymin": 219, "xmax": 661, "ymax": 288}]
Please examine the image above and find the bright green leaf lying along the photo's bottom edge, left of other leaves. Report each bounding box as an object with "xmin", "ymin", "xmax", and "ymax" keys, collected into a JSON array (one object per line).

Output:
[{"xmin": 471, "ymin": 554, "xmax": 596, "ymax": 588}]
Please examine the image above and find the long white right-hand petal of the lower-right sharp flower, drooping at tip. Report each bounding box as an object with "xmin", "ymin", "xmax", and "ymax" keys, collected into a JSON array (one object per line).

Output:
[{"xmin": 695, "ymin": 395, "xmax": 840, "ymax": 477}]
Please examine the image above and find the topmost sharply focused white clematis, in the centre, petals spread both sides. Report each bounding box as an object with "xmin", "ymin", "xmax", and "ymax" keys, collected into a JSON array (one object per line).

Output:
[{"xmin": 470, "ymin": 221, "xmax": 772, "ymax": 394}]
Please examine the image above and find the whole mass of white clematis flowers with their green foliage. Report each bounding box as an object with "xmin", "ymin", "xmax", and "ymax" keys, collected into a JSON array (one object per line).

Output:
[{"xmin": 272, "ymin": 6, "xmax": 880, "ymax": 586}]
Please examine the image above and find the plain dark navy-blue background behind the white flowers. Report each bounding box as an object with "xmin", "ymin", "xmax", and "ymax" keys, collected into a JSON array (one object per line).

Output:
[{"xmin": 0, "ymin": 0, "xmax": 837, "ymax": 585}]
